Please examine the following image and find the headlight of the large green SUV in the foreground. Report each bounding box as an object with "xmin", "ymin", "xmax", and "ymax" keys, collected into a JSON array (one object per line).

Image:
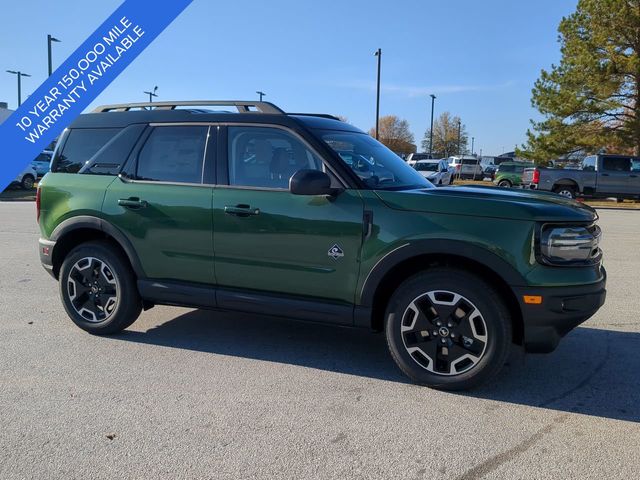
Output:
[{"xmin": 540, "ymin": 224, "xmax": 602, "ymax": 265}]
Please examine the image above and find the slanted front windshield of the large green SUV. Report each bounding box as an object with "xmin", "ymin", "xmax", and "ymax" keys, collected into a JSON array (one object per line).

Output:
[{"xmin": 317, "ymin": 130, "xmax": 433, "ymax": 190}]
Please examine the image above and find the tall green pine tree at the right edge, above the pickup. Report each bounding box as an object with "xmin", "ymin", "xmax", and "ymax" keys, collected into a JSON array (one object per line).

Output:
[{"xmin": 519, "ymin": 0, "xmax": 640, "ymax": 160}]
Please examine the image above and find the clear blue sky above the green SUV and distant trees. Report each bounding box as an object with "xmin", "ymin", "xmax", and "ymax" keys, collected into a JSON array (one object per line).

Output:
[{"xmin": 0, "ymin": 0, "xmax": 577, "ymax": 155}]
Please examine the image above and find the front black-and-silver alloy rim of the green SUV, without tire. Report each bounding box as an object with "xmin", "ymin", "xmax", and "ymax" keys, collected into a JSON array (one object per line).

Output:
[{"xmin": 400, "ymin": 290, "xmax": 488, "ymax": 376}]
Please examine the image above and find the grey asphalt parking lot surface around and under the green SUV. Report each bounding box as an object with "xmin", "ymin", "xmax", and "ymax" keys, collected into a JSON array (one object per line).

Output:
[{"xmin": 0, "ymin": 202, "xmax": 640, "ymax": 479}]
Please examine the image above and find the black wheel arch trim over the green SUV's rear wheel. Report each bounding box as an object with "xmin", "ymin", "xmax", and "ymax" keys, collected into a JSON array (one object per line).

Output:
[{"xmin": 50, "ymin": 215, "xmax": 145, "ymax": 278}]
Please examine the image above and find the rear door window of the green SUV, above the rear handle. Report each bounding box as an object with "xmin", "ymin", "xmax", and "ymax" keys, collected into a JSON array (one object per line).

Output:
[{"xmin": 136, "ymin": 126, "xmax": 209, "ymax": 183}]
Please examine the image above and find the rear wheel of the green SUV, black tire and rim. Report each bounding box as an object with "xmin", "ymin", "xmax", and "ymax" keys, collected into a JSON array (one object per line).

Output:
[{"xmin": 59, "ymin": 241, "xmax": 142, "ymax": 335}]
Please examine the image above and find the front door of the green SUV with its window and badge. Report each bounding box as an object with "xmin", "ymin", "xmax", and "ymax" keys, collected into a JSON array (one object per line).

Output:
[{"xmin": 214, "ymin": 126, "xmax": 363, "ymax": 304}]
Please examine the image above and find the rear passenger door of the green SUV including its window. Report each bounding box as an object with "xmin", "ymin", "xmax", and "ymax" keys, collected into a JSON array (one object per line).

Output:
[{"xmin": 103, "ymin": 124, "xmax": 217, "ymax": 284}]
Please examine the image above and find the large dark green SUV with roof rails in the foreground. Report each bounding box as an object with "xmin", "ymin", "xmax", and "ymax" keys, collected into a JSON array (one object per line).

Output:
[{"xmin": 37, "ymin": 101, "xmax": 606, "ymax": 390}]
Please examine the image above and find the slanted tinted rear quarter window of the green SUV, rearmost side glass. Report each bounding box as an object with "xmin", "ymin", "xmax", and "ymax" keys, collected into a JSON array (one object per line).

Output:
[{"xmin": 51, "ymin": 128, "xmax": 120, "ymax": 173}]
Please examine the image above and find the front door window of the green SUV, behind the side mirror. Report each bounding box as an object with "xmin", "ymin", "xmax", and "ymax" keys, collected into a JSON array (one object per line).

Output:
[{"xmin": 228, "ymin": 127, "xmax": 322, "ymax": 189}]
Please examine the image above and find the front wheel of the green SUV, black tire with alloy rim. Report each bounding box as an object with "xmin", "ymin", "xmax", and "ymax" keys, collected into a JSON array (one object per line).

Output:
[{"xmin": 385, "ymin": 267, "xmax": 512, "ymax": 390}]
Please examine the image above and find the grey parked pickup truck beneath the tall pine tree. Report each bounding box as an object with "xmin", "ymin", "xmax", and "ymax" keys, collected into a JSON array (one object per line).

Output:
[{"xmin": 522, "ymin": 155, "xmax": 640, "ymax": 199}]
